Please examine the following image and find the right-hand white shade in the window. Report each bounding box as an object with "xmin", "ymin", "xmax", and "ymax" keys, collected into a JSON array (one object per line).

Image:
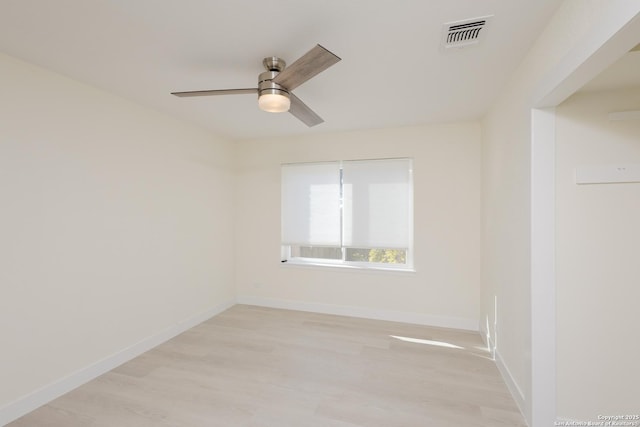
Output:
[{"xmin": 342, "ymin": 159, "xmax": 413, "ymax": 249}]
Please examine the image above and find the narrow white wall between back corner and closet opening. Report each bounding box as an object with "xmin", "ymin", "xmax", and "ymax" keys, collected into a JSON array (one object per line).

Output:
[{"xmin": 481, "ymin": 90, "xmax": 531, "ymax": 412}]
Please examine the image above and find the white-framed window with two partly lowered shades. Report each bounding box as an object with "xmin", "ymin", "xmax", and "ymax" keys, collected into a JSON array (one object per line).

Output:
[{"xmin": 282, "ymin": 159, "xmax": 413, "ymax": 270}]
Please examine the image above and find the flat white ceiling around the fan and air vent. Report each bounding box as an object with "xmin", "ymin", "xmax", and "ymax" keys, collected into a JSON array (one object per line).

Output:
[{"xmin": 0, "ymin": 0, "xmax": 561, "ymax": 139}]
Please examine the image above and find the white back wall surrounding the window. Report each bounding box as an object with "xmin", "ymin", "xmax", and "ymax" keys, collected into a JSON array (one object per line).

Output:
[{"xmin": 236, "ymin": 122, "xmax": 480, "ymax": 329}]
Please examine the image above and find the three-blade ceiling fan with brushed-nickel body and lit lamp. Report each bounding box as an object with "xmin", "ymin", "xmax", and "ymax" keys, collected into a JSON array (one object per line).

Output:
[{"xmin": 171, "ymin": 45, "xmax": 340, "ymax": 127}]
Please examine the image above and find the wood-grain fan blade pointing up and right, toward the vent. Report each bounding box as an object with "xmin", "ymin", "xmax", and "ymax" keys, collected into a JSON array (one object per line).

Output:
[{"xmin": 273, "ymin": 45, "xmax": 340, "ymax": 91}]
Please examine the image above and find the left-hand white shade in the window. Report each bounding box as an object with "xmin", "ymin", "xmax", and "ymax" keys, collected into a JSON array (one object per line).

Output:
[{"xmin": 281, "ymin": 162, "xmax": 340, "ymax": 246}]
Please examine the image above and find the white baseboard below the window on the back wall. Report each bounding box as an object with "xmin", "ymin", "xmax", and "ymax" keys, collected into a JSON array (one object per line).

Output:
[{"xmin": 238, "ymin": 296, "xmax": 479, "ymax": 332}]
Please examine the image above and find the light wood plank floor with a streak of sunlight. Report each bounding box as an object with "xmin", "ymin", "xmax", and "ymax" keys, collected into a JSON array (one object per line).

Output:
[{"xmin": 9, "ymin": 305, "xmax": 526, "ymax": 427}]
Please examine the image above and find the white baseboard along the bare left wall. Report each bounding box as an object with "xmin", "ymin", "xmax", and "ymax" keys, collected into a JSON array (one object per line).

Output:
[{"xmin": 0, "ymin": 300, "xmax": 235, "ymax": 426}]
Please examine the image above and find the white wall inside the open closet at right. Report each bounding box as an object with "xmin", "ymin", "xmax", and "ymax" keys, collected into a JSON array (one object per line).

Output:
[{"xmin": 556, "ymin": 88, "xmax": 640, "ymax": 421}]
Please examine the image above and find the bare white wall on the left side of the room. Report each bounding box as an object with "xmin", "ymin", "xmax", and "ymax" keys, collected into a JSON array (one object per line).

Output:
[{"xmin": 0, "ymin": 51, "xmax": 234, "ymax": 424}]
